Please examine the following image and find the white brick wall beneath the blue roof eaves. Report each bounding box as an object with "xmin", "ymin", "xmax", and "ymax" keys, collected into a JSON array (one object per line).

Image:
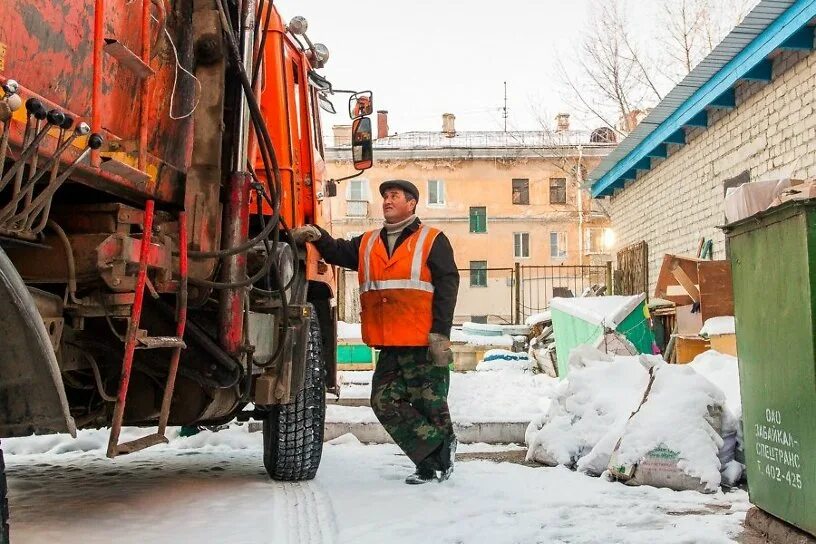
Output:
[{"xmin": 609, "ymin": 47, "xmax": 816, "ymax": 292}]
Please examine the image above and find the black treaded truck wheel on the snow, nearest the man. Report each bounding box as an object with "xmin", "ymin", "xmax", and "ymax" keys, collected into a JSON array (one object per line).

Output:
[{"xmin": 263, "ymin": 306, "xmax": 326, "ymax": 482}]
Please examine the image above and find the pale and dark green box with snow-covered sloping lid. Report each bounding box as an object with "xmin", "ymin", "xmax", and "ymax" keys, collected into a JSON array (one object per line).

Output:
[{"xmin": 550, "ymin": 295, "xmax": 654, "ymax": 378}]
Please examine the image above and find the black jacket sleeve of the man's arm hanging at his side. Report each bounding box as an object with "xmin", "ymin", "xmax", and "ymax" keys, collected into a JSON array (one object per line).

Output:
[{"xmin": 428, "ymin": 232, "xmax": 459, "ymax": 337}]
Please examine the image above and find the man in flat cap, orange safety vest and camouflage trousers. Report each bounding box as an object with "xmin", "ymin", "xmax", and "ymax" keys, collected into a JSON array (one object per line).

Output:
[{"xmin": 293, "ymin": 180, "xmax": 459, "ymax": 484}]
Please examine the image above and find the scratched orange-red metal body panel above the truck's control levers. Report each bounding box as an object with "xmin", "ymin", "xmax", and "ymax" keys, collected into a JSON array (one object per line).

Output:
[{"xmin": 0, "ymin": 0, "xmax": 198, "ymax": 204}]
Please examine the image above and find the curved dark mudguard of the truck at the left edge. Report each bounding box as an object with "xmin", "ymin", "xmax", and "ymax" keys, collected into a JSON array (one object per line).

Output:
[{"xmin": 0, "ymin": 249, "xmax": 76, "ymax": 437}]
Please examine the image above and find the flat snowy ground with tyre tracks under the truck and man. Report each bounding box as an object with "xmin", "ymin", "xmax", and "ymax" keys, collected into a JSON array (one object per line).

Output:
[{"xmin": 4, "ymin": 427, "xmax": 749, "ymax": 544}]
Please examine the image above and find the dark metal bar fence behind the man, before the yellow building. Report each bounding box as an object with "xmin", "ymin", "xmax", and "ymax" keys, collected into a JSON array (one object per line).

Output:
[{"xmin": 338, "ymin": 263, "xmax": 612, "ymax": 324}]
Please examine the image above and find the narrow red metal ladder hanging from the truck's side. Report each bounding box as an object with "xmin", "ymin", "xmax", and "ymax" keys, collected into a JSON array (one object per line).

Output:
[{"xmin": 107, "ymin": 200, "xmax": 187, "ymax": 459}]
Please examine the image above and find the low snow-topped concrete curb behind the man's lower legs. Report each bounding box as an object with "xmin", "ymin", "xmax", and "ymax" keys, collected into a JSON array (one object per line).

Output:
[{"xmin": 323, "ymin": 421, "xmax": 528, "ymax": 444}]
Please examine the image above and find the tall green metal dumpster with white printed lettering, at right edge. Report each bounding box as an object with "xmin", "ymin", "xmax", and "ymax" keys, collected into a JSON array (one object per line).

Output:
[{"xmin": 725, "ymin": 200, "xmax": 816, "ymax": 534}]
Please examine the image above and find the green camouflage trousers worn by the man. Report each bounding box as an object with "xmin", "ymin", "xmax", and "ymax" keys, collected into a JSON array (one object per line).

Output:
[{"xmin": 371, "ymin": 347, "xmax": 453, "ymax": 464}]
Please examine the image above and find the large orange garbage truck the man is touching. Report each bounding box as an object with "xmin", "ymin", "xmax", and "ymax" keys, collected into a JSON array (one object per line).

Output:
[{"xmin": 0, "ymin": 0, "xmax": 372, "ymax": 536}]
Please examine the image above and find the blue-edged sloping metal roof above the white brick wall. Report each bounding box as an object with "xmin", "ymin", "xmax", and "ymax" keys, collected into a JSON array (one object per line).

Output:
[{"xmin": 589, "ymin": 0, "xmax": 816, "ymax": 197}]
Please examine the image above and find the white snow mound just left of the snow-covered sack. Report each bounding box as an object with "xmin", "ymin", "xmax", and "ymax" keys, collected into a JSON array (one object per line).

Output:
[{"xmin": 526, "ymin": 346, "xmax": 649, "ymax": 470}]
